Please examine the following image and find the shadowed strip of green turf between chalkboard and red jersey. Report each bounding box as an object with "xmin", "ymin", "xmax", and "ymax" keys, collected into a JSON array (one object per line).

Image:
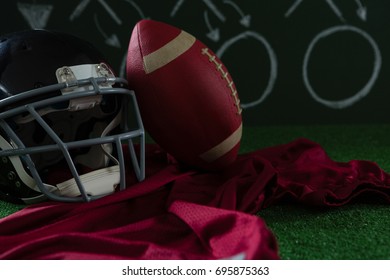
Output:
[{"xmin": 241, "ymin": 125, "xmax": 390, "ymax": 171}]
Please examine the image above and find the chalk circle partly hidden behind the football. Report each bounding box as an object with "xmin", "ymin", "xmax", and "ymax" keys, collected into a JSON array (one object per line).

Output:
[{"xmin": 216, "ymin": 31, "xmax": 278, "ymax": 109}]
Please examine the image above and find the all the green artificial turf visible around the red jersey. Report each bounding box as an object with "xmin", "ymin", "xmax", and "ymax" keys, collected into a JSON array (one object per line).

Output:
[{"xmin": 0, "ymin": 124, "xmax": 390, "ymax": 260}]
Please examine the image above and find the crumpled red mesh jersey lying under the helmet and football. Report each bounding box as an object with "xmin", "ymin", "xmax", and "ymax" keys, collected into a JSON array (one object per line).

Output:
[{"xmin": 0, "ymin": 139, "xmax": 390, "ymax": 259}]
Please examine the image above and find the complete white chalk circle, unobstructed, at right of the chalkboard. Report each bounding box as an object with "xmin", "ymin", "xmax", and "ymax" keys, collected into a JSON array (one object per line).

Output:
[{"xmin": 302, "ymin": 25, "xmax": 382, "ymax": 109}]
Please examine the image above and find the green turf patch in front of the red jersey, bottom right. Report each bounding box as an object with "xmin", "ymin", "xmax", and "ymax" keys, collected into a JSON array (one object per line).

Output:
[{"xmin": 258, "ymin": 204, "xmax": 390, "ymax": 260}]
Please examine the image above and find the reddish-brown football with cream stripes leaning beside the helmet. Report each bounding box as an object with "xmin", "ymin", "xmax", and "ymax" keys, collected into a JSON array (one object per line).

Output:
[{"xmin": 126, "ymin": 19, "xmax": 242, "ymax": 170}]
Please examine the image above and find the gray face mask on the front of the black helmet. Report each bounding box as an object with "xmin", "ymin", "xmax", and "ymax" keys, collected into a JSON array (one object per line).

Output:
[{"xmin": 0, "ymin": 64, "xmax": 145, "ymax": 203}]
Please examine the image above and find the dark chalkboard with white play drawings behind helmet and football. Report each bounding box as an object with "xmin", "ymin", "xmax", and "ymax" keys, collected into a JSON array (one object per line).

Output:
[{"xmin": 0, "ymin": 0, "xmax": 390, "ymax": 125}]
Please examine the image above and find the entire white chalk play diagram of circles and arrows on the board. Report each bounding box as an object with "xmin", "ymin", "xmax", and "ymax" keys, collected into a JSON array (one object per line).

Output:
[{"xmin": 17, "ymin": 0, "xmax": 382, "ymax": 109}]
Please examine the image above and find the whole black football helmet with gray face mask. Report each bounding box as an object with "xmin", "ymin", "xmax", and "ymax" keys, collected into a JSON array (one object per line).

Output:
[{"xmin": 0, "ymin": 30, "xmax": 145, "ymax": 203}]
